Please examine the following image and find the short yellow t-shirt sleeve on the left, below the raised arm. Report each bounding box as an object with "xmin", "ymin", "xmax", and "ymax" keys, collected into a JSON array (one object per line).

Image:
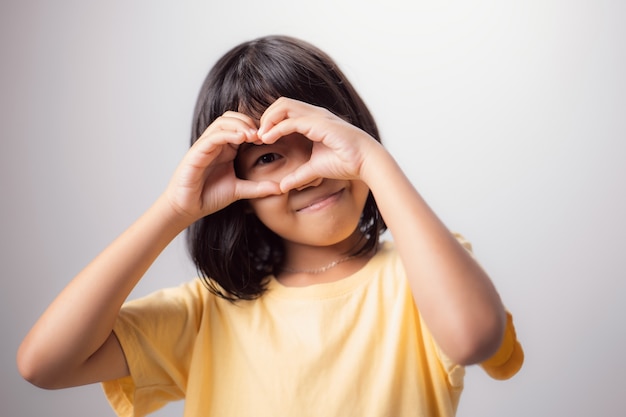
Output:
[{"xmin": 102, "ymin": 283, "xmax": 200, "ymax": 417}]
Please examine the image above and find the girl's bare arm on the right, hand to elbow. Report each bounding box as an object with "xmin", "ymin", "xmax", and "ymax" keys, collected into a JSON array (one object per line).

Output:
[{"xmin": 259, "ymin": 99, "xmax": 505, "ymax": 364}]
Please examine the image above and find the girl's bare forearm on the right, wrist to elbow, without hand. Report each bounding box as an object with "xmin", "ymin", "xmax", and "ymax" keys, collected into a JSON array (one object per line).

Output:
[{"xmin": 364, "ymin": 143, "xmax": 505, "ymax": 364}]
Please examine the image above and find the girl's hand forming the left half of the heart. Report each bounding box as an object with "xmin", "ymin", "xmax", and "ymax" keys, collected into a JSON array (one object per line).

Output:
[{"xmin": 165, "ymin": 111, "xmax": 280, "ymax": 223}]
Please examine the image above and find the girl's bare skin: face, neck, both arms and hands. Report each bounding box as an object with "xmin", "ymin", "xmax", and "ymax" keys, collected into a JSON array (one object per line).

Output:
[{"xmin": 17, "ymin": 98, "xmax": 505, "ymax": 388}]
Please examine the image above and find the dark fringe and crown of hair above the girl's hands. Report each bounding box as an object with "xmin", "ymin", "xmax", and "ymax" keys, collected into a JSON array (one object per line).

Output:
[{"xmin": 192, "ymin": 37, "xmax": 358, "ymax": 142}]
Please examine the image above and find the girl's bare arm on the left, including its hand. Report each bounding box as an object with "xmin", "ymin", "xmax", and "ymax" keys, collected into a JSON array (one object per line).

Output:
[{"xmin": 17, "ymin": 112, "xmax": 279, "ymax": 388}]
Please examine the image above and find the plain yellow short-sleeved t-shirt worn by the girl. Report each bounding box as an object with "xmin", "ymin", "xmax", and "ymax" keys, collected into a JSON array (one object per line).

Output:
[{"xmin": 103, "ymin": 242, "xmax": 523, "ymax": 417}]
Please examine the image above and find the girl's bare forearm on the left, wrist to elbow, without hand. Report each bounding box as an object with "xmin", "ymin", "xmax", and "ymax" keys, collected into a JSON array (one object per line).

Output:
[{"xmin": 18, "ymin": 195, "xmax": 184, "ymax": 386}]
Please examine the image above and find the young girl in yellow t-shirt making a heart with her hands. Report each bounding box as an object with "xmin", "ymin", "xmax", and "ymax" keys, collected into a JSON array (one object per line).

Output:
[{"xmin": 18, "ymin": 36, "xmax": 523, "ymax": 416}]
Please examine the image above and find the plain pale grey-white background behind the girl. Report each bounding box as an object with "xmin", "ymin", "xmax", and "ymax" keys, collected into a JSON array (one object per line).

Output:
[{"xmin": 0, "ymin": 0, "xmax": 626, "ymax": 417}]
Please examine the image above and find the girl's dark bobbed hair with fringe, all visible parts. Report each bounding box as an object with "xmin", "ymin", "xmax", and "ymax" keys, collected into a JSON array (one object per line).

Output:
[{"xmin": 187, "ymin": 36, "xmax": 386, "ymax": 301}]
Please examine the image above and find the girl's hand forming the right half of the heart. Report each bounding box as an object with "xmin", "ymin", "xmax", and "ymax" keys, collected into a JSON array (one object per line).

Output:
[{"xmin": 258, "ymin": 97, "xmax": 380, "ymax": 192}]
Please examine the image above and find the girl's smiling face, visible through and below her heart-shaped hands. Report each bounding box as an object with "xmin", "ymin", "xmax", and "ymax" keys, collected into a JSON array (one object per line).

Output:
[{"xmin": 236, "ymin": 134, "xmax": 369, "ymax": 246}]
